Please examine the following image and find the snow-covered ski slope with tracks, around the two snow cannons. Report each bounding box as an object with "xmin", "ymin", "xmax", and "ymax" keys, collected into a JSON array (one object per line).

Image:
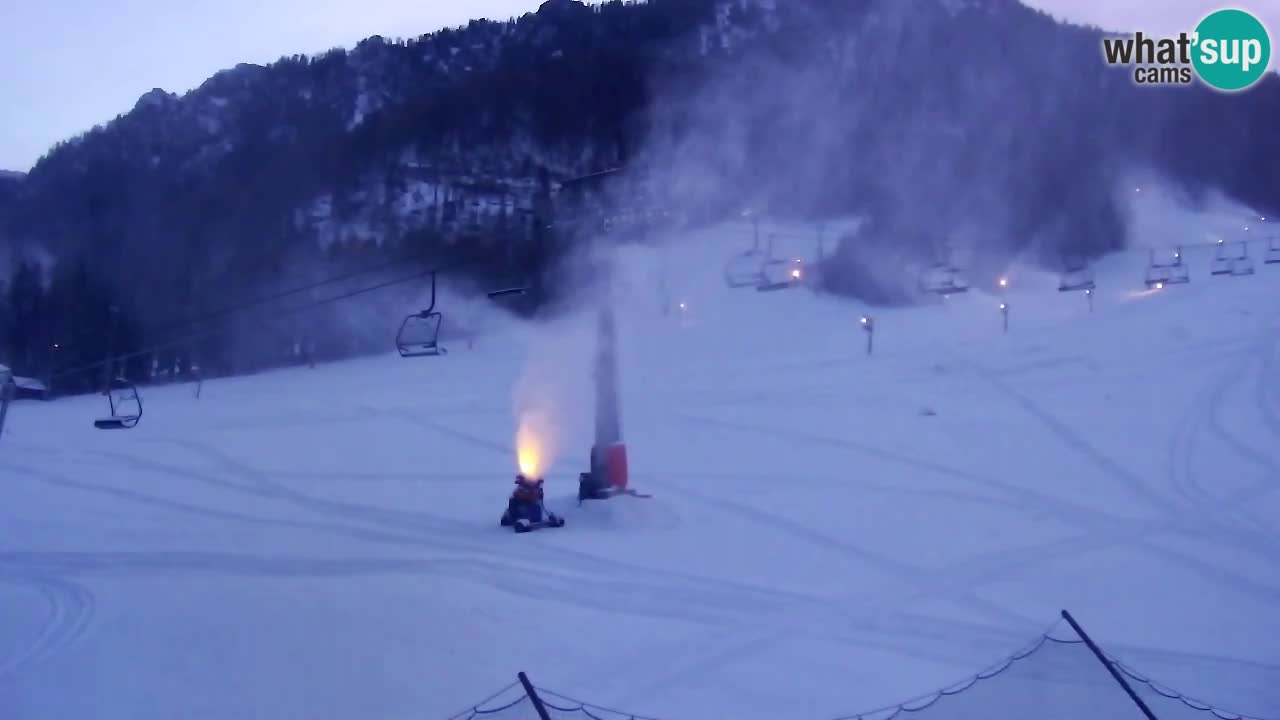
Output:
[{"xmin": 0, "ymin": 210, "xmax": 1280, "ymax": 720}]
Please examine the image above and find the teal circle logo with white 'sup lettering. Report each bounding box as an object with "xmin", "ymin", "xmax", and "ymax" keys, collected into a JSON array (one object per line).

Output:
[{"xmin": 1192, "ymin": 10, "xmax": 1271, "ymax": 92}]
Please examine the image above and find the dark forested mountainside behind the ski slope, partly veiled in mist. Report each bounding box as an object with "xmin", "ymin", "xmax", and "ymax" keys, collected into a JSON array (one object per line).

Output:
[{"xmin": 0, "ymin": 0, "xmax": 1280, "ymax": 389}]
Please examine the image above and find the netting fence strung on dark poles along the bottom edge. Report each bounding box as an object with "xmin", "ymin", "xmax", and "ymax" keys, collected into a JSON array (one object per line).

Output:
[{"xmin": 449, "ymin": 614, "xmax": 1280, "ymax": 720}]
